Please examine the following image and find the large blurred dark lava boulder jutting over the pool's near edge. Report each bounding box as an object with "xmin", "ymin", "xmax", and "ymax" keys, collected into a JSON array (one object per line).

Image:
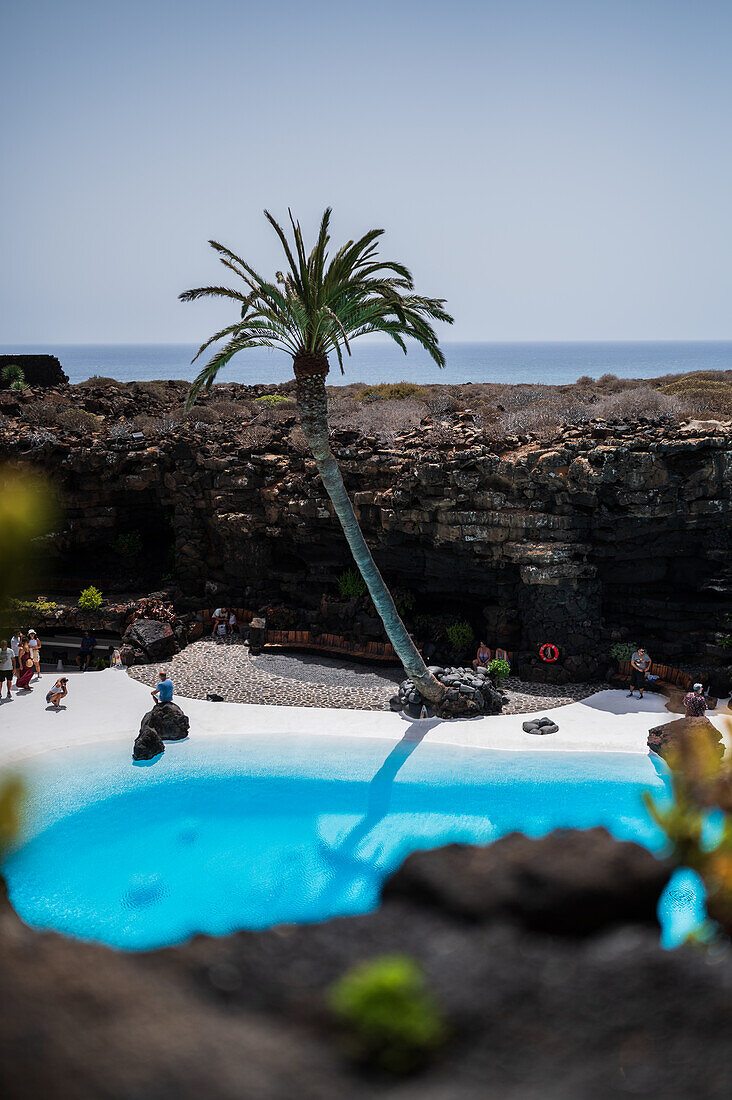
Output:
[{"xmin": 382, "ymin": 827, "xmax": 671, "ymax": 936}]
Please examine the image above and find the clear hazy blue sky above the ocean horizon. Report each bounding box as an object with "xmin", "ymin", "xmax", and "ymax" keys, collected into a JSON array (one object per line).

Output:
[{"xmin": 0, "ymin": 0, "xmax": 732, "ymax": 343}]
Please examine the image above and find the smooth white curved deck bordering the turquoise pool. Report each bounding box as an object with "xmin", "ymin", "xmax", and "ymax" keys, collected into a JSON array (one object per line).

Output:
[{"xmin": 0, "ymin": 669, "xmax": 732, "ymax": 768}]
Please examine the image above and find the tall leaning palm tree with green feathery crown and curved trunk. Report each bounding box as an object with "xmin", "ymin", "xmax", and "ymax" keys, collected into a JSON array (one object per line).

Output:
[{"xmin": 181, "ymin": 209, "xmax": 452, "ymax": 703}]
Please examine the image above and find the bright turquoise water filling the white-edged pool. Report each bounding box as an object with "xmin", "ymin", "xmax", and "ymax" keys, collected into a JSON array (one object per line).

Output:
[{"xmin": 4, "ymin": 737, "xmax": 702, "ymax": 949}]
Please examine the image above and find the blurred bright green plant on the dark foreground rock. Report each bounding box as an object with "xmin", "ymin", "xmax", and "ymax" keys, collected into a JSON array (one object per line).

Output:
[{"xmin": 328, "ymin": 955, "xmax": 447, "ymax": 1074}]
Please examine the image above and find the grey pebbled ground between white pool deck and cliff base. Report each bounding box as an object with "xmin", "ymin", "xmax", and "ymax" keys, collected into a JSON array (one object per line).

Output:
[{"xmin": 129, "ymin": 638, "xmax": 608, "ymax": 714}]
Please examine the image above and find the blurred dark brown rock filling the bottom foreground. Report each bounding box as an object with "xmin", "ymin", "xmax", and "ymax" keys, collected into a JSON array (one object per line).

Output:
[{"xmin": 0, "ymin": 829, "xmax": 732, "ymax": 1100}]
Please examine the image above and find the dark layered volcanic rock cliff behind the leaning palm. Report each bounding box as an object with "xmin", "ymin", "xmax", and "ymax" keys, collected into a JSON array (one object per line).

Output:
[{"xmin": 0, "ymin": 383, "xmax": 732, "ymax": 679}]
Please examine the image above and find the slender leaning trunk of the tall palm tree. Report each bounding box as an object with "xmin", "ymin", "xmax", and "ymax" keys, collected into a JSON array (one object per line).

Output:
[{"xmin": 295, "ymin": 355, "xmax": 445, "ymax": 703}]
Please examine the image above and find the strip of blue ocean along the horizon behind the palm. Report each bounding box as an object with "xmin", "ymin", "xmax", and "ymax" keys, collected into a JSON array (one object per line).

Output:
[{"xmin": 0, "ymin": 341, "xmax": 732, "ymax": 385}]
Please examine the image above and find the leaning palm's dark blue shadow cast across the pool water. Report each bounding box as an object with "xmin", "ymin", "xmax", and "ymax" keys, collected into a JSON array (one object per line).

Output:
[{"xmin": 310, "ymin": 718, "xmax": 440, "ymax": 919}]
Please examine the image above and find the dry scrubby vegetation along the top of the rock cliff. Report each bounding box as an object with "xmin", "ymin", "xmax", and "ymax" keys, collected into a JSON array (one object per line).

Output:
[{"xmin": 7, "ymin": 371, "xmax": 732, "ymax": 444}]
